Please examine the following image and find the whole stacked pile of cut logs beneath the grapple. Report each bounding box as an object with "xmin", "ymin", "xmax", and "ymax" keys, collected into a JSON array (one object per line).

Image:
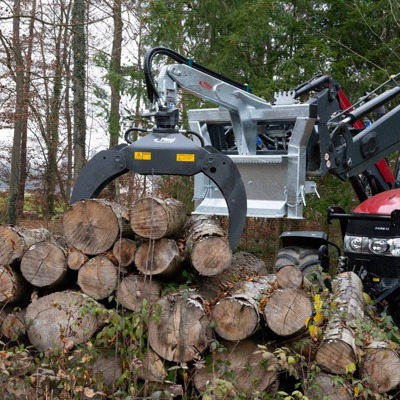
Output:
[{"xmin": 0, "ymin": 198, "xmax": 400, "ymax": 399}]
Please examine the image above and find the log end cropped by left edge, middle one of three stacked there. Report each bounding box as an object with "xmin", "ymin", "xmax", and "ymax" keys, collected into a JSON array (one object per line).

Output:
[{"xmin": 0, "ymin": 265, "xmax": 32, "ymax": 304}]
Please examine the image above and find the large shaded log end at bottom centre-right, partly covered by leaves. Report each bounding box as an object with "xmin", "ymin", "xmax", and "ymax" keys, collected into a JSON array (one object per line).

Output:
[{"xmin": 192, "ymin": 339, "xmax": 278, "ymax": 398}]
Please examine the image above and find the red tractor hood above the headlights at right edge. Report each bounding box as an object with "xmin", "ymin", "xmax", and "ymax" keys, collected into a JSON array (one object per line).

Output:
[{"xmin": 353, "ymin": 189, "xmax": 400, "ymax": 215}]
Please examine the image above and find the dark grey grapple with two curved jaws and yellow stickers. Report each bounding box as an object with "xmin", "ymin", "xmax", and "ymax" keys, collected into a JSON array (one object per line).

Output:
[{"xmin": 71, "ymin": 131, "xmax": 247, "ymax": 248}]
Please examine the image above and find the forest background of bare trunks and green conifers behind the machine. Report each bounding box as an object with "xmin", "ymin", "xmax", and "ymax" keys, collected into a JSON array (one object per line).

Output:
[{"xmin": 0, "ymin": 0, "xmax": 400, "ymax": 260}]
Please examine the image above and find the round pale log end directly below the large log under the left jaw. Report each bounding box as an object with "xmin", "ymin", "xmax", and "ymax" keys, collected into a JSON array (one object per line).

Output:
[{"xmin": 78, "ymin": 255, "xmax": 118, "ymax": 300}]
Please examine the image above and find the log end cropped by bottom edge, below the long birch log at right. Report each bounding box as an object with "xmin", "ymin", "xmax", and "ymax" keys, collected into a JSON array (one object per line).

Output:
[{"xmin": 304, "ymin": 373, "xmax": 353, "ymax": 400}]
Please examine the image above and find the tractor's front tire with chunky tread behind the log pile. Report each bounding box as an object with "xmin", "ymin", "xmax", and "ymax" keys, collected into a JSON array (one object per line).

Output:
[{"xmin": 275, "ymin": 246, "xmax": 326, "ymax": 290}]
